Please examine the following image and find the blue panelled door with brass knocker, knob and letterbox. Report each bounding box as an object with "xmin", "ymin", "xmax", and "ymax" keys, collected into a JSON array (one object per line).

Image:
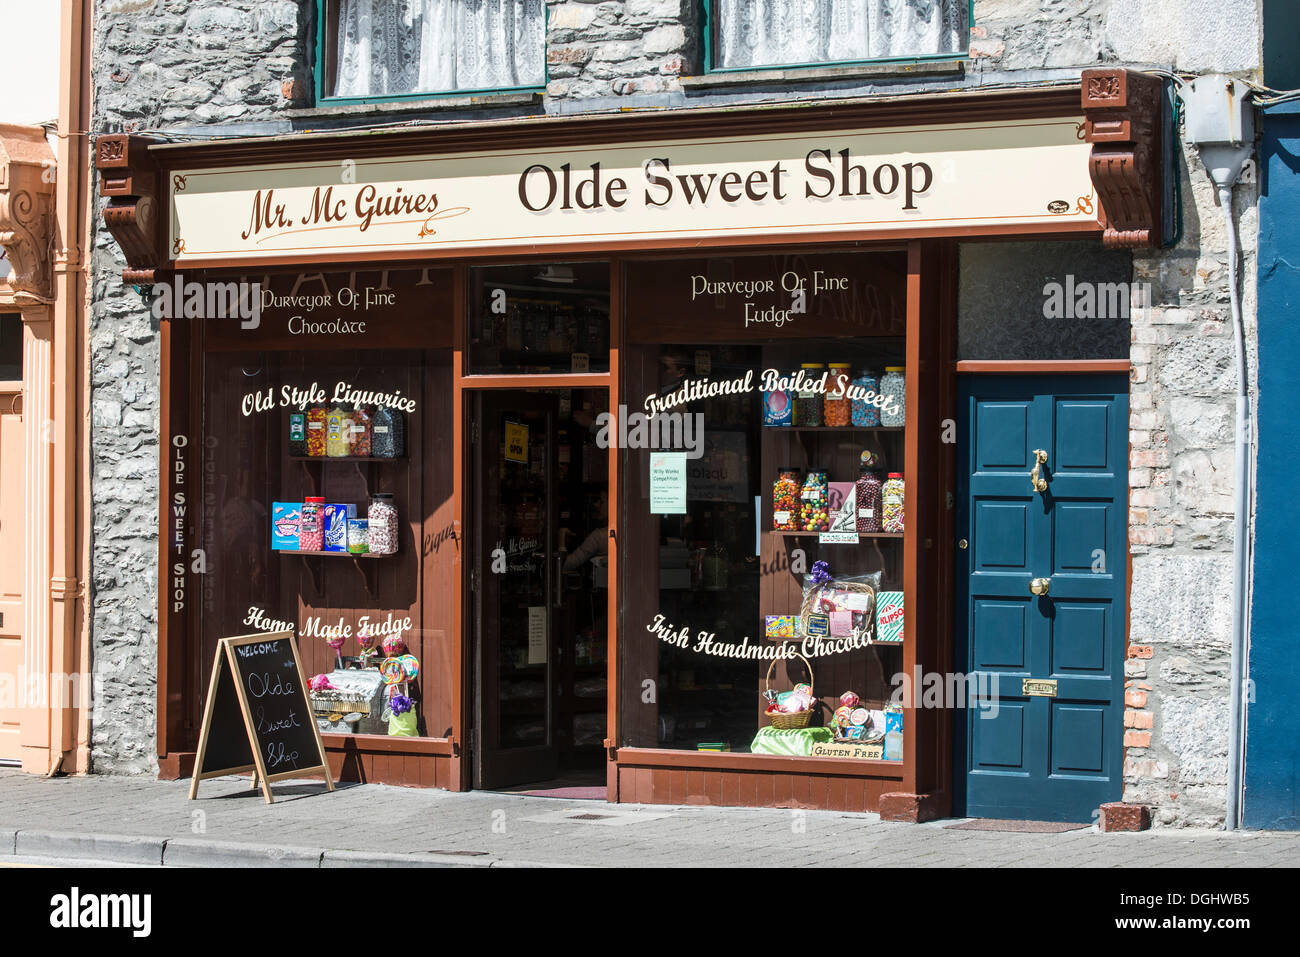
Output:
[{"xmin": 954, "ymin": 374, "xmax": 1128, "ymax": 822}]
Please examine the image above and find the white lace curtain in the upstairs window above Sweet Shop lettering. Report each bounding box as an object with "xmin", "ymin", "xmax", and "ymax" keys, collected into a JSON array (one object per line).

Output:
[{"xmin": 712, "ymin": 0, "xmax": 969, "ymax": 68}]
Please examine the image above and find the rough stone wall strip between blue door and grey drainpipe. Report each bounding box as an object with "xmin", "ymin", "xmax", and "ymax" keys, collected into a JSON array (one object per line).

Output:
[{"xmin": 1125, "ymin": 151, "xmax": 1258, "ymax": 826}]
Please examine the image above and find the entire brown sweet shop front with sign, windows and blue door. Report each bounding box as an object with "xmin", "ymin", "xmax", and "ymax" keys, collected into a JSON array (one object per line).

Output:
[{"xmin": 99, "ymin": 72, "xmax": 1160, "ymax": 820}]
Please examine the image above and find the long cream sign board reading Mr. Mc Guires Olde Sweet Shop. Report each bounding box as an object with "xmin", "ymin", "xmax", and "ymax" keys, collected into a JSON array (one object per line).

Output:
[{"xmin": 168, "ymin": 117, "xmax": 1100, "ymax": 268}]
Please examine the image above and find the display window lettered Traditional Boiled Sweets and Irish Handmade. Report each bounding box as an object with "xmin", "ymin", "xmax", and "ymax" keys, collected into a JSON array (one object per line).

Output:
[{"xmin": 620, "ymin": 254, "xmax": 909, "ymax": 759}]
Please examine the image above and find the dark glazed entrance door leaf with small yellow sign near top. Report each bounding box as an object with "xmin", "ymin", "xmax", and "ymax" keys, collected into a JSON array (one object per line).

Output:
[{"xmin": 471, "ymin": 390, "xmax": 562, "ymax": 788}]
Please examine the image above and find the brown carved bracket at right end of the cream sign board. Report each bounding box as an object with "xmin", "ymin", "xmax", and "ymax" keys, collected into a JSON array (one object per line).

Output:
[{"xmin": 1083, "ymin": 69, "xmax": 1166, "ymax": 247}]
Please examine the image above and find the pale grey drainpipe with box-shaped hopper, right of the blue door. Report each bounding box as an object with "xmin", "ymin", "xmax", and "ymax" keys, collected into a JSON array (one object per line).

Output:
[{"xmin": 1178, "ymin": 75, "xmax": 1255, "ymax": 831}]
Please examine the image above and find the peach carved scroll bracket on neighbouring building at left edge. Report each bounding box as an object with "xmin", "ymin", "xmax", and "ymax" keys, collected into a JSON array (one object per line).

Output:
[{"xmin": 0, "ymin": 124, "xmax": 57, "ymax": 303}]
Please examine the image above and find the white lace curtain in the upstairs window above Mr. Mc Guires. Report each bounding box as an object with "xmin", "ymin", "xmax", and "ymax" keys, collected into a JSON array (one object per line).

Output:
[{"xmin": 333, "ymin": 0, "xmax": 546, "ymax": 96}]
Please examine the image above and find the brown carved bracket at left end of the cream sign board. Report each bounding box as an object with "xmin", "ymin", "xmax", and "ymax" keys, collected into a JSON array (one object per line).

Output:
[{"xmin": 95, "ymin": 133, "xmax": 166, "ymax": 286}]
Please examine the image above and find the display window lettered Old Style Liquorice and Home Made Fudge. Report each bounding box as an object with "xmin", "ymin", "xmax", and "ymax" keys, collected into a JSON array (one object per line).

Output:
[{"xmin": 195, "ymin": 270, "xmax": 458, "ymax": 737}]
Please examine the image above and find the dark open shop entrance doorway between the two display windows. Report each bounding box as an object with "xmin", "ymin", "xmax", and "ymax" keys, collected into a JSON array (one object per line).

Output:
[{"xmin": 469, "ymin": 389, "xmax": 608, "ymax": 788}]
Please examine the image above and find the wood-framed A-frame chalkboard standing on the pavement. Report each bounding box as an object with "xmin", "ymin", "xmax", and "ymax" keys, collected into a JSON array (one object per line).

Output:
[{"xmin": 190, "ymin": 632, "xmax": 334, "ymax": 804}]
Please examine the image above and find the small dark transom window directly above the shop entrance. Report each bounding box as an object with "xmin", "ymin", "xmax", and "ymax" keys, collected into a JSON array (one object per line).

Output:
[{"xmin": 469, "ymin": 263, "xmax": 610, "ymax": 374}]
